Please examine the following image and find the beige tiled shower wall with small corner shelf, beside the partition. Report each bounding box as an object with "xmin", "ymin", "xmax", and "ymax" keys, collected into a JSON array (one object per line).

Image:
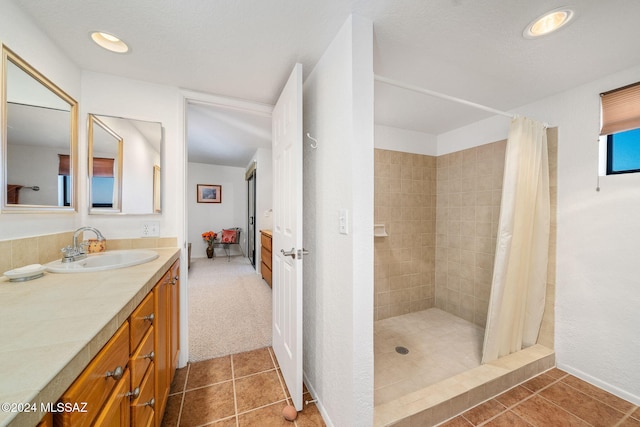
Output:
[{"xmin": 374, "ymin": 149, "xmax": 436, "ymax": 320}]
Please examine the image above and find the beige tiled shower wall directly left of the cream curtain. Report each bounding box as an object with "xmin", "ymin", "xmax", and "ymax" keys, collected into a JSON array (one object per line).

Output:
[{"xmin": 435, "ymin": 141, "xmax": 506, "ymax": 327}]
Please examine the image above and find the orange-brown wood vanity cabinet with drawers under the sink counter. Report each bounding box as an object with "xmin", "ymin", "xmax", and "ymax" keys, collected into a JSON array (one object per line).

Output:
[{"xmin": 53, "ymin": 260, "xmax": 180, "ymax": 427}]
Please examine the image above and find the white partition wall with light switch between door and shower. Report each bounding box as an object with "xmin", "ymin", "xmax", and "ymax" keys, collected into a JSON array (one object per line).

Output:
[{"xmin": 303, "ymin": 16, "xmax": 374, "ymax": 426}]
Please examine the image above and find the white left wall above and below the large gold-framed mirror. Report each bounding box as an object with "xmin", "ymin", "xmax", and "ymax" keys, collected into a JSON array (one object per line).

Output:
[{"xmin": 0, "ymin": 1, "xmax": 80, "ymax": 240}]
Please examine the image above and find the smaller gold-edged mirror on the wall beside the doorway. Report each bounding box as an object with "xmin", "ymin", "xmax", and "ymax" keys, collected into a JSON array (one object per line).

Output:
[{"xmin": 87, "ymin": 114, "xmax": 163, "ymax": 214}]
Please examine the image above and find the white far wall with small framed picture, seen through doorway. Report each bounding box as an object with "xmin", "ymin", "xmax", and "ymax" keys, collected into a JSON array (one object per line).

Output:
[{"xmin": 187, "ymin": 162, "xmax": 247, "ymax": 258}]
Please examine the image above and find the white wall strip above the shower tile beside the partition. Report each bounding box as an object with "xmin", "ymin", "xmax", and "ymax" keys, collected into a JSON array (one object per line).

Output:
[{"xmin": 374, "ymin": 125, "xmax": 438, "ymax": 156}]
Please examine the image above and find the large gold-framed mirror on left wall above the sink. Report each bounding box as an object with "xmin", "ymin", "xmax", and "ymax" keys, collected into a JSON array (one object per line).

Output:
[{"xmin": 0, "ymin": 45, "xmax": 78, "ymax": 213}]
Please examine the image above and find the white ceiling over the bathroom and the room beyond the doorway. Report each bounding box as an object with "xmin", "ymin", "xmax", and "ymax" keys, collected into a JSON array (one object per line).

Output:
[{"xmin": 13, "ymin": 0, "xmax": 640, "ymax": 165}]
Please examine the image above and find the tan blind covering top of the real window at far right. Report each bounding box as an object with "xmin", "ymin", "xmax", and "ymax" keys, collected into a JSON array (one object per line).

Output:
[{"xmin": 600, "ymin": 82, "xmax": 640, "ymax": 135}]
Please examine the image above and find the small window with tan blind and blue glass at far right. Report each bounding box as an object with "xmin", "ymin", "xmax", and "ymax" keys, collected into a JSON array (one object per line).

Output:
[{"xmin": 600, "ymin": 82, "xmax": 640, "ymax": 175}]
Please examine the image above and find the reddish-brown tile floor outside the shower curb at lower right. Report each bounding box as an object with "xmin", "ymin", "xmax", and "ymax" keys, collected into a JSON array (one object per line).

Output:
[{"xmin": 440, "ymin": 368, "xmax": 640, "ymax": 427}]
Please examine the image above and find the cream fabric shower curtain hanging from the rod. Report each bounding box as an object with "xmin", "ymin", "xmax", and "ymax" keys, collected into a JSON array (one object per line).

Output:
[{"xmin": 482, "ymin": 117, "xmax": 550, "ymax": 363}]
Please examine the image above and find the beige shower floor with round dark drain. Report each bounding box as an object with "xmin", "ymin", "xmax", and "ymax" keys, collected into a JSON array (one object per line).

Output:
[{"xmin": 374, "ymin": 308, "xmax": 484, "ymax": 405}]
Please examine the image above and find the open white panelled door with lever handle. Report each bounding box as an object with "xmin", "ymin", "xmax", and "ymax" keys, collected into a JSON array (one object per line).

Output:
[{"xmin": 272, "ymin": 64, "xmax": 302, "ymax": 411}]
